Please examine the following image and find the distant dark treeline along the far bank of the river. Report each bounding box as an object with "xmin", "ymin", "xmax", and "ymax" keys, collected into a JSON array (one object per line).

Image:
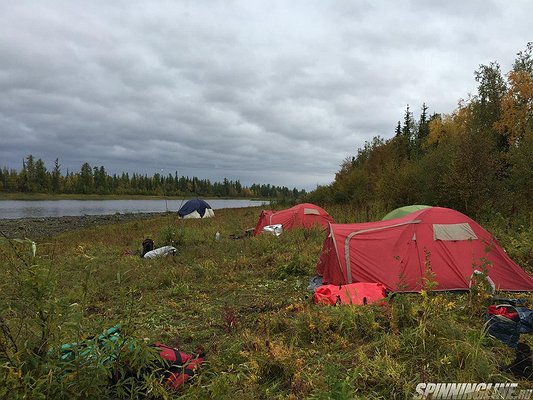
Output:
[{"xmin": 0, "ymin": 154, "xmax": 305, "ymax": 202}]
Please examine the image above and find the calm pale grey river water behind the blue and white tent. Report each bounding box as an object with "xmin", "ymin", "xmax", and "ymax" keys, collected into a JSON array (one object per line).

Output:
[{"xmin": 0, "ymin": 199, "xmax": 267, "ymax": 219}]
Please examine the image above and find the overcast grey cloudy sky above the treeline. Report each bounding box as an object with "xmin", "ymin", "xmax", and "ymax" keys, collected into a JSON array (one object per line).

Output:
[{"xmin": 0, "ymin": 0, "xmax": 533, "ymax": 190}]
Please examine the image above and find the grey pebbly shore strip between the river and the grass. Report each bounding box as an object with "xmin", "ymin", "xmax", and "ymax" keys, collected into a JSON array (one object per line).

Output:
[{"xmin": 0, "ymin": 213, "xmax": 165, "ymax": 240}]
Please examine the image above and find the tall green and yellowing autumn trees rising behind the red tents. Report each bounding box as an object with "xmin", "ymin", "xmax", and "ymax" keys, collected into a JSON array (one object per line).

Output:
[{"xmin": 308, "ymin": 43, "xmax": 533, "ymax": 217}]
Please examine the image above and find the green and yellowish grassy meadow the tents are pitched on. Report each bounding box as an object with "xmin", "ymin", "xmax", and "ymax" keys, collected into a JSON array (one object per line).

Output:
[{"xmin": 0, "ymin": 206, "xmax": 533, "ymax": 399}]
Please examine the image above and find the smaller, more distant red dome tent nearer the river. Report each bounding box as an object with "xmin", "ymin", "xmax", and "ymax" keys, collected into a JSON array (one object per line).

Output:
[{"xmin": 254, "ymin": 203, "xmax": 335, "ymax": 236}]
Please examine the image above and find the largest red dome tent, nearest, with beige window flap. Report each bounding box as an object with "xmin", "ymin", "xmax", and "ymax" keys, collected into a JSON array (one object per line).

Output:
[{"xmin": 317, "ymin": 207, "xmax": 533, "ymax": 292}]
